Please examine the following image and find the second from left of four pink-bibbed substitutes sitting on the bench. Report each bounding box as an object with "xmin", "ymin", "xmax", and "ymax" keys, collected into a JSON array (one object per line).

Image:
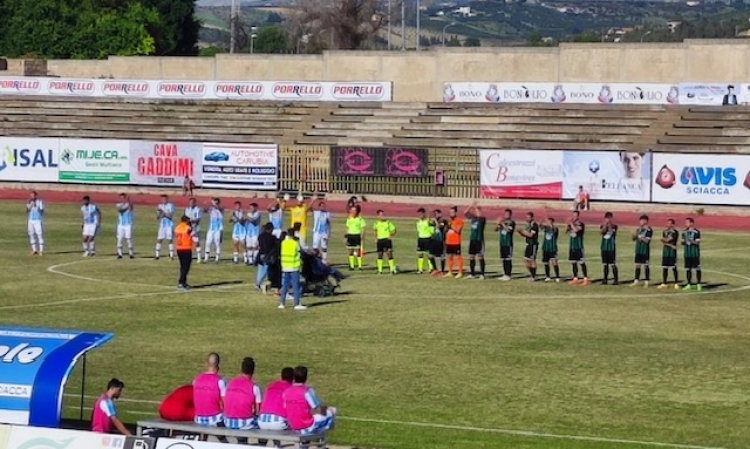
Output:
[{"xmin": 224, "ymin": 357, "xmax": 262, "ymax": 430}]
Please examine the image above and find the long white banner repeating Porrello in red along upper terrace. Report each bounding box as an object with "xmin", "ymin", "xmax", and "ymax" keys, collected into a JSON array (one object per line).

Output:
[{"xmin": 0, "ymin": 77, "xmax": 393, "ymax": 102}]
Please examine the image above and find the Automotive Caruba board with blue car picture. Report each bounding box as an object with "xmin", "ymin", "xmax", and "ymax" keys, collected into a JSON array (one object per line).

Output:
[{"xmin": 201, "ymin": 143, "xmax": 279, "ymax": 190}]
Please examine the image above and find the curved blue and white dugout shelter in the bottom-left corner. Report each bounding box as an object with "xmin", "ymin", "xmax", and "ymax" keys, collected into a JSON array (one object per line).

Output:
[{"xmin": 0, "ymin": 327, "xmax": 112, "ymax": 427}]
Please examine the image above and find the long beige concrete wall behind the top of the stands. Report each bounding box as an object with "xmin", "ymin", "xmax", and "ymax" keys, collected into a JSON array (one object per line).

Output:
[{"xmin": 16, "ymin": 39, "xmax": 750, "ymax": 102}]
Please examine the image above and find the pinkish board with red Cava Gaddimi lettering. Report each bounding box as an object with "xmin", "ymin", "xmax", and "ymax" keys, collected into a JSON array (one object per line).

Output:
[{"xmin": 130, "ymin": 140, "xmax": 203, "ymax": 187}]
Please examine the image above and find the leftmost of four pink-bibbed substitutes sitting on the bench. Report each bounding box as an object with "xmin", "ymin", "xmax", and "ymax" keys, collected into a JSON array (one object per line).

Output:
[{"xmin": 193, "ymin": 352, "xmax": 227, "ymax": 426}]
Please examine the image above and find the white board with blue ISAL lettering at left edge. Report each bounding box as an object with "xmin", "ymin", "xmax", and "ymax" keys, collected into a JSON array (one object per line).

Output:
[{"xmin": 0, "ymin": 137, "xmax": 60, "ymax": 182}]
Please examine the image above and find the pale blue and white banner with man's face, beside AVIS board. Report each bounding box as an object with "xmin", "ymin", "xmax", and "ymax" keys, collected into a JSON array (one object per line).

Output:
[{"xmin": 563, "ymin": 151, "xmax": 651, "ymax": 202}]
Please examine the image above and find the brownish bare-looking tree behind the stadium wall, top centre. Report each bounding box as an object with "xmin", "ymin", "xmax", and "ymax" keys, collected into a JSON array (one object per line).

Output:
[{"xmin": 292, "ymin": 0, "xmax": 387, "ymax": 50}]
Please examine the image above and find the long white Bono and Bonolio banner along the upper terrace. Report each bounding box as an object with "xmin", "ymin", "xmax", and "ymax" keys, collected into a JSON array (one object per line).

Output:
[{"xmin": 443, "ymin": 82, "xmax": 679, "ymax": 105}]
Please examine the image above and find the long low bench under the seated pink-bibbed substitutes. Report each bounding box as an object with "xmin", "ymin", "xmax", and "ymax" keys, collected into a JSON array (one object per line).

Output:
[{"xmin": 136, "ymin": 418, "xmax": 328, "ymax": 449}]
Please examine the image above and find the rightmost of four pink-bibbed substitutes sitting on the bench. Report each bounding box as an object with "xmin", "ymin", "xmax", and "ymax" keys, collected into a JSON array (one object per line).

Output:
[{"xmin": 283, "ymin": 366, "xmax": 336, "ymax": 435}]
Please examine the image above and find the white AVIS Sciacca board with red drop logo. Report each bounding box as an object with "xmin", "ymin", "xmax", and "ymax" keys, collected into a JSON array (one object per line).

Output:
[{"xmin": 652, "ymin": 153, "xmax": 750, "ymax": 206}]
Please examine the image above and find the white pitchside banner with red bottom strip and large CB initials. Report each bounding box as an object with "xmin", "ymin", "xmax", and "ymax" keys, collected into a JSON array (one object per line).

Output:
[{"xmin": 479, "ymin": 150, "xmax": 563, "ymax": 199}]
